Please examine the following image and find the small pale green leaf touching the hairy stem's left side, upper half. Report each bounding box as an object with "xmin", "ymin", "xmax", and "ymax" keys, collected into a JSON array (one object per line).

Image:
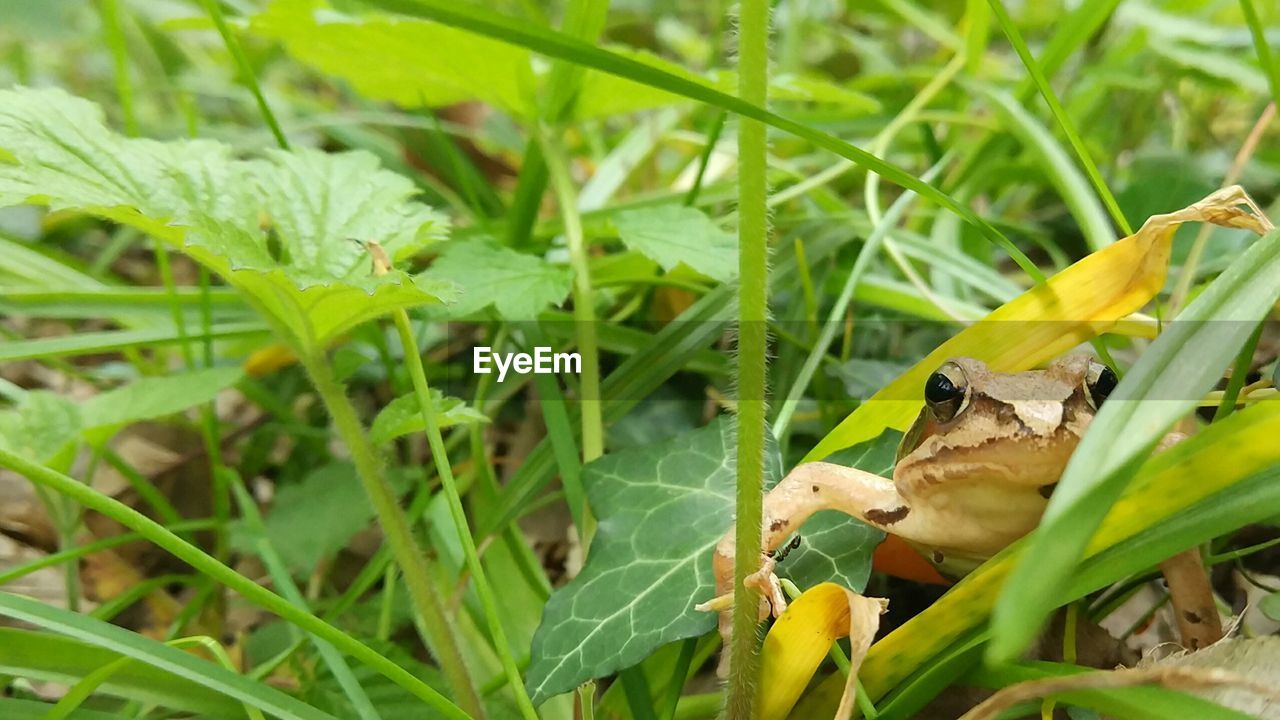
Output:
[{"xmin": 613, "ymin": 205, "xmax": 737, "ymax": 282}]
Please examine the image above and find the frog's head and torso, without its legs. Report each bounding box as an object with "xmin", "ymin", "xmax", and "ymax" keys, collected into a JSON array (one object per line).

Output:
[{"xmin": 890, "ymin": 355, "xmax": 1114, "ymax": 575}]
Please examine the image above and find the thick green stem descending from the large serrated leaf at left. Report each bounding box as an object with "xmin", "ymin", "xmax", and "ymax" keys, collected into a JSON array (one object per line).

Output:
[{"xmin": 300, "ymin": 346, "xmax": 485, "ymax": 717}]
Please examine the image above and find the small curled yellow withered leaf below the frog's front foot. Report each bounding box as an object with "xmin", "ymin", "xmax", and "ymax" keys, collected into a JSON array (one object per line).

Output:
[{"xmin": 760, "ymin": 583, "xmax": 884, "ymax": 720}]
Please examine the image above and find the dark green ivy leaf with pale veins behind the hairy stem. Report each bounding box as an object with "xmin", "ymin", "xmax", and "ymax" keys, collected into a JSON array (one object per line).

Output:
[{"xmin": 526, "ymin": 419, "xmax": 896, "ymax": 702}]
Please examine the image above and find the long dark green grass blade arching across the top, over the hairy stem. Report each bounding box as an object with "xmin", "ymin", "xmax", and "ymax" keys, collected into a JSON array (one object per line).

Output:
[{"xmin": 355, "ymin": 0, "xmax": 1043, "ymax": 281}]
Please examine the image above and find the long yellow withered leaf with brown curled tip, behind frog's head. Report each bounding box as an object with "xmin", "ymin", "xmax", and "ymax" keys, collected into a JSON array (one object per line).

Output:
[{"xmin": 804, "ymin": 186, "xmax": 1265, "ymax": 462}]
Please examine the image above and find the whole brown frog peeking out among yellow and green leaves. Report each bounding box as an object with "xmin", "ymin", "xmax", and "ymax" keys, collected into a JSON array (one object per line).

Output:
[{"xmin": 699, "ymin": 354, "xmax": 1221, "ymax": 646}]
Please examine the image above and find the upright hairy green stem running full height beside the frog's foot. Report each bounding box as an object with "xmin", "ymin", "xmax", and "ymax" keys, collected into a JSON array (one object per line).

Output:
[{"xmin": 727, "ymin": 0, "xmax": 769, "ymax": 719}]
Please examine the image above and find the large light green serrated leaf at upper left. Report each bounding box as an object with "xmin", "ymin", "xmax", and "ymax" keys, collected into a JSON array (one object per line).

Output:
[{"xmin": 0, "ymin": 88, "xmax": 453, "ymax": 355}]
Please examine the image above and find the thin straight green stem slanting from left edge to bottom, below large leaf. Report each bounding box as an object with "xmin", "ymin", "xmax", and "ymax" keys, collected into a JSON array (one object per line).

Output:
[{"xmin": 0, "ymin": 448, "xmax": 467, "ymax": 720}]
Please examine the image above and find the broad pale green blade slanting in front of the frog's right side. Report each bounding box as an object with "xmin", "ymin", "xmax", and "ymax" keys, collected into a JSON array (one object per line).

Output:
[{"xmin": 988, "ymin": 231, "xmax": 1280, "ymax": 661}]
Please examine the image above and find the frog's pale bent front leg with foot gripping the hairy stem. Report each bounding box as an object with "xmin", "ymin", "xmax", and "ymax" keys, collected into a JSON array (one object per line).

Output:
[{"xmin": 699, "ymin": 462, "xmax": 928, "ymax": 643}]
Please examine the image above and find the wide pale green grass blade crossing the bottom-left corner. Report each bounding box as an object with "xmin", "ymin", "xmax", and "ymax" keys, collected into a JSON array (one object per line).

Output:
[{"xmin": 0, "ymin": 593, "xmax": 333, "ymax": 720}]
